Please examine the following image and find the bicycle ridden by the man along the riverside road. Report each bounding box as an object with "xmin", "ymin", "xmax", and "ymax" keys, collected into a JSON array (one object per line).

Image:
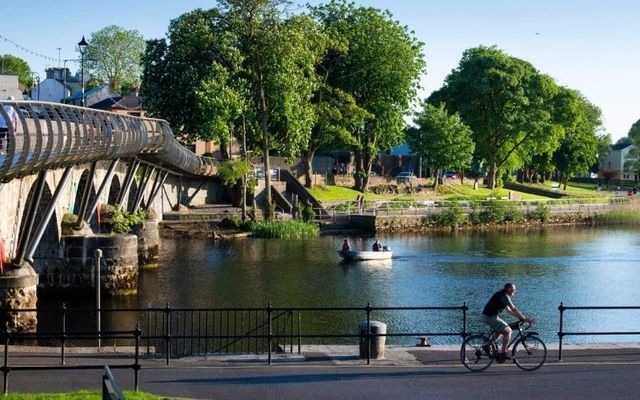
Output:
[{"xmin": 460, "ymin": 321, "xmax": 547, "ymax": 372}]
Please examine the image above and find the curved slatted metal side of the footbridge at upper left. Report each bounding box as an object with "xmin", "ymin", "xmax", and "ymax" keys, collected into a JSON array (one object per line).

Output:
[{"xmin": 0, "ymin": 101, "xmax": 217, "ymax": 182}]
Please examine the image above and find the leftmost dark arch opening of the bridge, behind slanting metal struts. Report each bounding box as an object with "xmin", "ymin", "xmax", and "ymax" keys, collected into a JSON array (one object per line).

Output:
[{"xmin": 20, "ymin": 181, "xmax": 61, "ymax": 276}]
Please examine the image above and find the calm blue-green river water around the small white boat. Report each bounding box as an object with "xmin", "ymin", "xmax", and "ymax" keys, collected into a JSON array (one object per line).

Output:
[{"xmin": 45, "ymin": 227, "xmax": 640, "ymax": 343}]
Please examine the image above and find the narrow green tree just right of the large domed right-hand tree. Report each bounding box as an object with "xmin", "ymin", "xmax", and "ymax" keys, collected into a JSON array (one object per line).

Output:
[{"xmin": 553, "ymin": 88, "xmax": 602, "ymax": 190}]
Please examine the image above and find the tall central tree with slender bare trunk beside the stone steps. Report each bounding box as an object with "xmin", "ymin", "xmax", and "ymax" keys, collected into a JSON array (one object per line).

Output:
[{"xmin": 219, "ymin": 0, "xmax": 326, "ymax": 218}]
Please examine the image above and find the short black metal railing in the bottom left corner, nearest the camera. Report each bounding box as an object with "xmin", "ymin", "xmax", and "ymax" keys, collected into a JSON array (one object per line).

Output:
[{"xmin": 0, "ymin": 326, "xmax": 142, "ymax": 395}]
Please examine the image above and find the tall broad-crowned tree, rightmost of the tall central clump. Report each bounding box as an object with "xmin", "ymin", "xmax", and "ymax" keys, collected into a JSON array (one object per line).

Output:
[{"xmin": 312, "ymin": 0, "xmax": 425, "ymax": 191}]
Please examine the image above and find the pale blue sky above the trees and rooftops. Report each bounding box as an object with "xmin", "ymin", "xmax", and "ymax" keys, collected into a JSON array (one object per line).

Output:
[{"xmin": 0, "ymin": 0, "xmax": 640, "ymax": 142}]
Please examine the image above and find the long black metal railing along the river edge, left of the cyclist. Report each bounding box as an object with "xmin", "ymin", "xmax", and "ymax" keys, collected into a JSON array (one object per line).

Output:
[{"xmin": 3, "ymin": 304, "xmax": 468, "ymax": 365}]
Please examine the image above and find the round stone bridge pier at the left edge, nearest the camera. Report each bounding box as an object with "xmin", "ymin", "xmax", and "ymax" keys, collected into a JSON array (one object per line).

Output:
[{"xmin": 0, "ymin": 263, "xmax": 38, "ymax": 332}]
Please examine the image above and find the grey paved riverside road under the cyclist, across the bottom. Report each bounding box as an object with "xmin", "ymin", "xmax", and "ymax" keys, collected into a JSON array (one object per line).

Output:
[{"xmin": 7, "ymin": 343, "xmax": 640, "ymax": 400}]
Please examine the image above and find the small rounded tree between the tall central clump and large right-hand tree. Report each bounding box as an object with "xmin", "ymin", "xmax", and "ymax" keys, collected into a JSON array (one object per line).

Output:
[{"xmin": 406, "ymin": 103, "xmax": 475, "ymax": 186}]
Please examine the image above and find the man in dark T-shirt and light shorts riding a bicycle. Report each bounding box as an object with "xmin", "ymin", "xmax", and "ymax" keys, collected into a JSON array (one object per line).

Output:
[{"xmin": 482, "ymin": 283, "xmax": 533, "ymax": 359}]
